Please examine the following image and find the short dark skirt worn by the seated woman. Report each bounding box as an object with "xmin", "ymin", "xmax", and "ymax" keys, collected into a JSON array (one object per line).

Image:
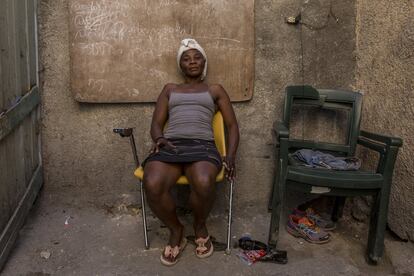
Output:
[{"xmin": 142, "ymin": 139, "xmax": 222, "ymax": 170}]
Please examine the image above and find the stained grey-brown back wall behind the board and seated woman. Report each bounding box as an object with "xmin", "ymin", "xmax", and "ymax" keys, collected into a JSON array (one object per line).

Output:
[{"xmin": 39, "ymin": 0, "xmax": 408, "ymax": 239}]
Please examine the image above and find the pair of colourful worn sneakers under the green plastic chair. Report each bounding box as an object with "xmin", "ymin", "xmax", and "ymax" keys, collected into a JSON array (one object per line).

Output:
[{"xmin": 286, "ymin": 208, "xmax": 336, "ymax": 244}]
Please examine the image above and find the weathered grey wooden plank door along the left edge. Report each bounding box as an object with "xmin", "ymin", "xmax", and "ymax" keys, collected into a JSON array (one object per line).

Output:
[{"xmin": 0, "ymin": 0, "xmax": 43, "ymax": 271}]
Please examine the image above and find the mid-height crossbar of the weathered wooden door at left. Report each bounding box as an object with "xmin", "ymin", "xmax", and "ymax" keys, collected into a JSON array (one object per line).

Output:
[{"xmin": 0, "ymin": 86, "xmax": 40, "ymax": 140}]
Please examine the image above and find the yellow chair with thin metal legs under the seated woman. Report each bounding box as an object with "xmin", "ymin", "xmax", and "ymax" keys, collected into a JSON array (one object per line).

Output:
[{"xmin": 118, "ymin": 111, "xmax": 234, "ymax": 254}]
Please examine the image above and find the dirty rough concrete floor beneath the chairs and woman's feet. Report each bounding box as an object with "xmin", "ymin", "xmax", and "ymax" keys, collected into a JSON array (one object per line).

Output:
[{"xmin": 2, "ymin": 190, "xmax": 414, "ymax": 276}]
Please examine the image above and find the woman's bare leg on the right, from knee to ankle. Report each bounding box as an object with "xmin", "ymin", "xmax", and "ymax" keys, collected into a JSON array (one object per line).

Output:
[{"xmin": 185, "ymin": 161, "xmax": 219, "ymax": 238}]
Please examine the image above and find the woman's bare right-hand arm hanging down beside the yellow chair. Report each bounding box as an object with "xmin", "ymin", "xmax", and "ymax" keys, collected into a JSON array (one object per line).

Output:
[{"xmin": 210, "ymin": 84, "xmax": 239, "ymax": 179}]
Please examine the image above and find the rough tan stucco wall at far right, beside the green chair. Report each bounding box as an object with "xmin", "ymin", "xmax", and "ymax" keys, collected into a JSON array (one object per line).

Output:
[{"xmin": 355, "ymin": 0, "xmax": 414, "ymax": 240}]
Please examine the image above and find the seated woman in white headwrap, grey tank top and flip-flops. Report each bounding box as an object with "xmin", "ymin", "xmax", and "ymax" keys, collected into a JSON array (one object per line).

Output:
[{"xmin": 144, "ymin": 39, "xmax": 239, "ymax": 265}]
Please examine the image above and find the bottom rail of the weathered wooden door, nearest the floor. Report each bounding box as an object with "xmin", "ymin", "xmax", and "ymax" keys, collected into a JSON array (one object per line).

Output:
[{"xmin": 0, "ymin": 166, "xmax": 43, "ymax": 271}]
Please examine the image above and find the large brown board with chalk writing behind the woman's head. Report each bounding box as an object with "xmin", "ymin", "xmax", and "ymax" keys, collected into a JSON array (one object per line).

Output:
[{"xmin": 70, "ymin": 0, "xmax": 254, "ymax": 102}]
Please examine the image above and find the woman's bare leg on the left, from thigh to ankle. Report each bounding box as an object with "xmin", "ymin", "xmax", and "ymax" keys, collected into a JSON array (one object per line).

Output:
[{"xmin": 144, "ymin": 161, "xmax": 184, "ymax": 247}]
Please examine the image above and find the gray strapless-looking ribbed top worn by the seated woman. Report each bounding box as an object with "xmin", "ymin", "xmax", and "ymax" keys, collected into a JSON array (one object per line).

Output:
[{"xmin": 164, "ymin": 91, "xmax": 215, "ymax": 141}]
